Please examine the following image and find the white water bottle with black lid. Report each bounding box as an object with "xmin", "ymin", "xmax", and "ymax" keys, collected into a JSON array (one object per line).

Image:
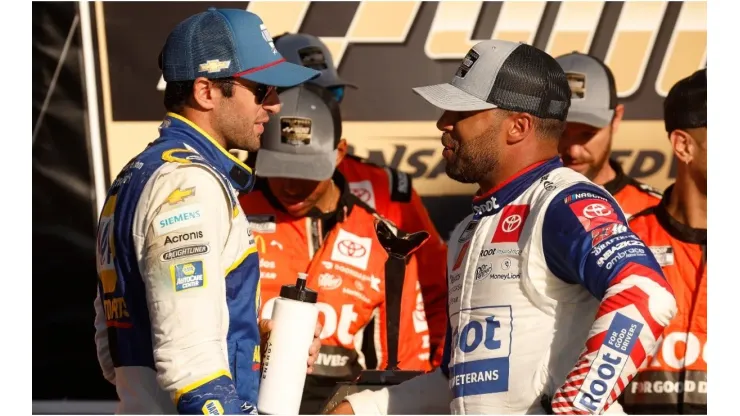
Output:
[{"xmin": 257, "ymin": 273, "xmax": 319, "ymax": 415}]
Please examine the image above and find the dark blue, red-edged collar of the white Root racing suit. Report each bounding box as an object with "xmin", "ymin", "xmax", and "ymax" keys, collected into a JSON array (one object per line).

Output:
[{"xmin": 473, "ymin": 156, "xmax": 563, "ymax": 219}]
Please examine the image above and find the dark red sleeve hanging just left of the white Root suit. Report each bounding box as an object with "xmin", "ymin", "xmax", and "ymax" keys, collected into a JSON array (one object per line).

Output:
[{"xmin": 399, "ymin": 189, "xmax": 447, "ymax": 365}]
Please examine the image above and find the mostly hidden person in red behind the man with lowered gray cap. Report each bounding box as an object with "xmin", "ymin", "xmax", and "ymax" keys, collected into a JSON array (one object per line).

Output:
[{"xmin": 268, "ymin": 33, "xmax": 447, "ymax": 366}]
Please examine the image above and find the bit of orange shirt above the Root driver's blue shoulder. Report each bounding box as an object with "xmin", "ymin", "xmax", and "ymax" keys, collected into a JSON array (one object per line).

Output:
[{"xmin": 604, "ymin": 160, "xmax": 662, "ymax": 219}]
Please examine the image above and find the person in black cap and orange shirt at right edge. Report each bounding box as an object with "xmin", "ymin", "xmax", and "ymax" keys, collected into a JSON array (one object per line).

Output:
[{"xmin": 622, "ymin": 69, "xmax": 707, "ymax": 414}]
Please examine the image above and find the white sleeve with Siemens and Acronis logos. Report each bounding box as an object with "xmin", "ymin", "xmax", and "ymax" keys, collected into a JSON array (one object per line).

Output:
[{"xmin": 134, "ymin": 165, "xmax": 253, "ymax": 414}]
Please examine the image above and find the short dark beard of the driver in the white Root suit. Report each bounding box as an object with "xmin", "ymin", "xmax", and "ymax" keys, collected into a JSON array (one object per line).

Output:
[{"xmin": 445, "ymin": 127, "xmax": 499, "ymax": 183}]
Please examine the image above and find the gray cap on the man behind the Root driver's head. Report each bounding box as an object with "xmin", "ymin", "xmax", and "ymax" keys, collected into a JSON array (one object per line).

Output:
[{"xmin": 555, "ymin": 52, "xmax": 617, "ymax": 128}]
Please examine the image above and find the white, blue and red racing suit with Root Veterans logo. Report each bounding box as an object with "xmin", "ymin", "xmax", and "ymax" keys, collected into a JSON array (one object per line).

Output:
[{"xmin": 347, "ymin": 158, "xmax": 676, "ymax": 414}]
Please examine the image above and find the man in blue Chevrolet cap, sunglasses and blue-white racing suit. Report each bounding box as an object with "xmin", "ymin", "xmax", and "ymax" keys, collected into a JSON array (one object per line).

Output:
[{"xmin": 95, "ymin": 8, "xmax": 318, "ymax": 414}]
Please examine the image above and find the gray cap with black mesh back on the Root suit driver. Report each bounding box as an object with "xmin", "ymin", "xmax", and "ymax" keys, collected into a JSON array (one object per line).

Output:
[{"xmin": 414, "ymin": 40, "xmax": 570, "ymax": 121}]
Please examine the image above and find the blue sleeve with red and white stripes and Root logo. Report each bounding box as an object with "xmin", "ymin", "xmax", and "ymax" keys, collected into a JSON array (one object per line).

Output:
[{"xmin": 542, "ymin": 184, "xmax": 676, "ymax": 414}]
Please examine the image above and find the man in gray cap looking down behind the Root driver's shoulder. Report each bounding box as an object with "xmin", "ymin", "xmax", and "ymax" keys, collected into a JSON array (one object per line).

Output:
[{"xmin": 555, "ymin": 52, "xmax": 661, "ymax": 218}]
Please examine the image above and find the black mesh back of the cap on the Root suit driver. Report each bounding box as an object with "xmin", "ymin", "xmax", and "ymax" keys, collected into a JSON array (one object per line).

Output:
[{"xmin": 488, "ymin": 44, "xmax": 570, "ymax": 121}]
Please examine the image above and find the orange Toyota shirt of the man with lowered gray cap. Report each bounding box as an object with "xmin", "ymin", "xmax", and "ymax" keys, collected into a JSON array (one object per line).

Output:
[{"xmin": 239, "ymin": 175, "xmax": 431, "ymax": 379}]
